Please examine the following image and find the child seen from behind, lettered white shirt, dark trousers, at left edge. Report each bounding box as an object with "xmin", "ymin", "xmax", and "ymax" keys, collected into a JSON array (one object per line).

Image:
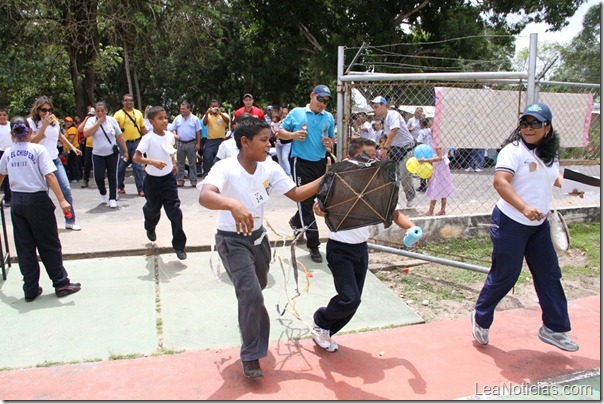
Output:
[{"xmin": 0, "ymin": 116, "xmax": 82, "ymax": 302}]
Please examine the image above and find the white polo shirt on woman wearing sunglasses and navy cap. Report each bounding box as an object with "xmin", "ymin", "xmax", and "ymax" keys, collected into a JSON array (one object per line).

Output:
[{"xmin": 495, "ymin": 140, "xmax": 560, "ymax": 226}]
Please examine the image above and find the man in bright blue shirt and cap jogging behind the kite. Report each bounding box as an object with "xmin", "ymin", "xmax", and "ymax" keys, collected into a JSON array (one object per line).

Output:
[{"xmin": 278, "ymin": 84, "xmax": 335, "ymax": 263}]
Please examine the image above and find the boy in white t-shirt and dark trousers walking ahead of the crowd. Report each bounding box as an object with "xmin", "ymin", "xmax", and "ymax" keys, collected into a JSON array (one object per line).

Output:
[{"xmin": 132, "ymin": 107, "xmax": 187, "ymax": 260}]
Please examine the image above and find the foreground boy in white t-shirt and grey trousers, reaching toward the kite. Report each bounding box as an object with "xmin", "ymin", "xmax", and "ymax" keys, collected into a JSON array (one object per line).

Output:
[{"xmin": 199, "ymin": 118, "xmax": 323, "ymax": 378}]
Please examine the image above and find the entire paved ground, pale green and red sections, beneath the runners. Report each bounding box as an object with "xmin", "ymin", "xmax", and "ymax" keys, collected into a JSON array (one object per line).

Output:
[{"xmin": 0, "ymin": 174, "xmax": 601, "ymax": 400}]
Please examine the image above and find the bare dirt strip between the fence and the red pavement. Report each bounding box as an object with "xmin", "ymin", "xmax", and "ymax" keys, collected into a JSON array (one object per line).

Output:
[{"xmin": 369, "ymin": 248, "xmax": 600, "ymax": 323}]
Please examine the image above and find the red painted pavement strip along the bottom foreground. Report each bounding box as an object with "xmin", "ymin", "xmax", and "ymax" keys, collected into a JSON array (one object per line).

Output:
[{"xmin": 0, "ymin": 296, "xmax": 601, "ymax": 400}]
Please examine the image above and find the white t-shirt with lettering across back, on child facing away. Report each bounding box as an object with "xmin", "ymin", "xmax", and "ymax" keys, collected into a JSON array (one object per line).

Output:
[{"xmin": 0, "ymin": 142, "xmax": 57, "ymax": 193}]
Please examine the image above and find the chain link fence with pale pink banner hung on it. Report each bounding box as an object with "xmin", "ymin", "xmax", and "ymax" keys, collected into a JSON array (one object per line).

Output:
[{"xmin": 341, "ymin": 78, "xmax": 600, "ymax": 217}]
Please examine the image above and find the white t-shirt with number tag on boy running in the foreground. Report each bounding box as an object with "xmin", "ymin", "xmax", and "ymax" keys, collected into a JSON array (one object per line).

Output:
[{"xmin": 201, "ymin": 157, "xmax": 296, "ymax": 232}]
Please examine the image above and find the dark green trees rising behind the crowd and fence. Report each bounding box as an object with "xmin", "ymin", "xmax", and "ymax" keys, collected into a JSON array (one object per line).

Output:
[{"xmin": 0, "ymin": 0, "xmax": 599, "ymax": 114}]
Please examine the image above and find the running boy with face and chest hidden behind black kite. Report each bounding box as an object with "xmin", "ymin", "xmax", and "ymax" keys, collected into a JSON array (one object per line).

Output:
[{"xmin": 313, "ymin": 138, "xmax": 421, "ymax": 352}]
